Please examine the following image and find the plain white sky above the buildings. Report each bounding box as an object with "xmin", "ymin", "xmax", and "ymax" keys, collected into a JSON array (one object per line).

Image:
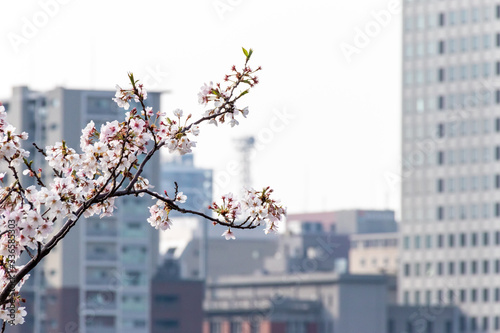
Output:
[{"xmin": 0, "ymin": 0, "xmax": 401, "ymax": 212}]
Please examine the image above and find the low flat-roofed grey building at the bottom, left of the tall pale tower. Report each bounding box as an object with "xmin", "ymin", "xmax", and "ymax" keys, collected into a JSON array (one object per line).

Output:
[{"xmin": 205, "ymin": 273, "xmax": 387, "ymax": 333}]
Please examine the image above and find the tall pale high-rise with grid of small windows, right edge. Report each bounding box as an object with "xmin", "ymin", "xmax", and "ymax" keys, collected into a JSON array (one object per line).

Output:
[{"xmin": 398, "ymin": 0, "xmax": 500, "ymax": 332}]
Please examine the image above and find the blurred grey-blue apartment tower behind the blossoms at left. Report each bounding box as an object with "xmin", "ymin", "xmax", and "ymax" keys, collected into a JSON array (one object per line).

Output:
[{"xmin": 7, "ymin": 87, "xmax": 160, "ymax": 333}]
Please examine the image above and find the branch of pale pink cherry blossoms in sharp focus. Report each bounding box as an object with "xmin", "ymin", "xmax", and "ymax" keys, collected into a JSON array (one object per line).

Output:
[{"xmin": 0, "ymin": 49, "xmax": 286, "ymax": 328}]
